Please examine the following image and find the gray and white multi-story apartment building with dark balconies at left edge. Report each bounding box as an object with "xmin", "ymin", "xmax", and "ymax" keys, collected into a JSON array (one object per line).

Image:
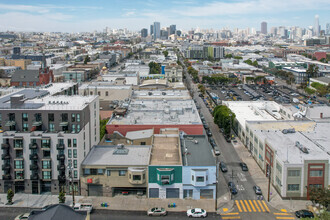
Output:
[{"xmin": 0, "ymin": 84, "xmax": 99, "ymax": 194}]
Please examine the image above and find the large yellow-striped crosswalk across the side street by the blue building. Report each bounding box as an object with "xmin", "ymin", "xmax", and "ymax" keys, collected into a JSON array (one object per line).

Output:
[{"xmin": 235, "ymin": 200, "xmax": 270, "ymax": 213}]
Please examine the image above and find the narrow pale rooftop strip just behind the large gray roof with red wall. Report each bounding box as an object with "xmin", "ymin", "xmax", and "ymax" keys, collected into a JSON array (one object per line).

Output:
[{"xmin": 132, "ymin": 89, "xmax": 191, "ymax": 99}]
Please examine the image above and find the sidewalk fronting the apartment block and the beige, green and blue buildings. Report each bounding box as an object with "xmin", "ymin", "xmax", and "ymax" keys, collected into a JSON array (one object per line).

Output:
[{"xmin": 0, "ymin": 193, "xmax": 215, "ymax": 212}]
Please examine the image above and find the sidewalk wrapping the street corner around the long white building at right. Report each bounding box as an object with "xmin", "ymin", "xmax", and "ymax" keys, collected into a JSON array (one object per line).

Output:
[{"xmin": 233, "ymin": 138, "xmax": 312, "ymax": 212}]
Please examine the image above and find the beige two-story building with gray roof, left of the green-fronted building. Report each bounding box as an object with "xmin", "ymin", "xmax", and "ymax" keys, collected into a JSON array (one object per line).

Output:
[{"xmin": 80, "ymin": 145, "xmax": 151, "ymax": 197}]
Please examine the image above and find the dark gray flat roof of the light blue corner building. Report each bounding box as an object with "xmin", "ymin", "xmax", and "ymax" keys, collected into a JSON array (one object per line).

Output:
[{"xmin": 181, "ymin": 135, "xmax": 216, "ymax": 166}]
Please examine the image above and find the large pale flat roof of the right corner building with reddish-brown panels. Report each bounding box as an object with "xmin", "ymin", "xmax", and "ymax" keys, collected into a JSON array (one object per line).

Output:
[{"xmin": 248, "ymin": 121, "xmax": 330, "ymax": 164}]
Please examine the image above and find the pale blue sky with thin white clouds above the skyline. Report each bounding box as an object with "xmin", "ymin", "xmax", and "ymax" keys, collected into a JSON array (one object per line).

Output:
[{"xmin": 0, "ymin": 0, "xmax": 330, "ymax": 32}]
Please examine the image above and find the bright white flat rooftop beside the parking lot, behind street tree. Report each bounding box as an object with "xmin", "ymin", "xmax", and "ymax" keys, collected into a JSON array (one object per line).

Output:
[{"xmin": 223, "ymin": 101, "xmax": 278, "ymax": 128}]
